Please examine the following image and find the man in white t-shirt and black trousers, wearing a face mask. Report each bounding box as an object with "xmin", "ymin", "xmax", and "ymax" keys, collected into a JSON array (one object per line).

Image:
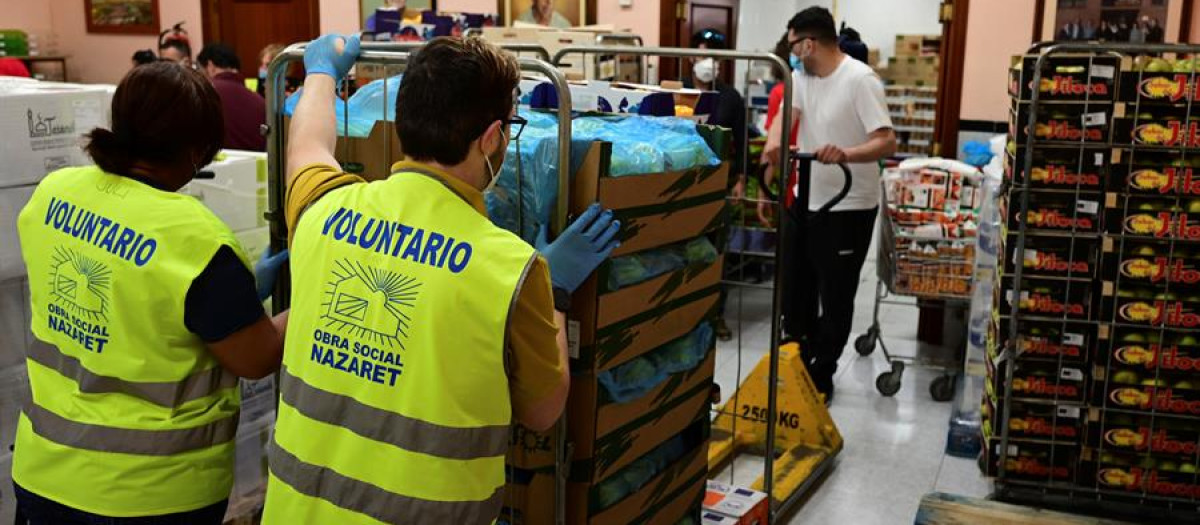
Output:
[{"xmin": 763, "ymin": 7, "xmax": 896, "ymax": 402}]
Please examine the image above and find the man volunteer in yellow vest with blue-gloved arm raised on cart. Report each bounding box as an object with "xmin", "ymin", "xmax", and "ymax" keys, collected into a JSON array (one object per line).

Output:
[{"xmin": 263, "ymin": 35, "xmax": 619, "ymax": 525}]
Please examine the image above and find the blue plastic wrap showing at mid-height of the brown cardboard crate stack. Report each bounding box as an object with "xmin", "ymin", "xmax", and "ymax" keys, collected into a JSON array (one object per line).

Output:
[{"xmin": 596, "ymin": 322, "xmax": 713, "ymax": 403}]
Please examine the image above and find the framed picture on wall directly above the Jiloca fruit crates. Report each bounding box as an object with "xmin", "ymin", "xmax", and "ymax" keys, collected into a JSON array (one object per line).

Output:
[{"xmin": 1033, "ymin": 0, "xmax": 1193, "ymax": 43}]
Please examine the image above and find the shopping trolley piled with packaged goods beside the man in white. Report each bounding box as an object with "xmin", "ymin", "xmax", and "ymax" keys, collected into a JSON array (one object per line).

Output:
[{"xmin": 854, "ymin": 158, "xmax": 982, "ymax": 402}]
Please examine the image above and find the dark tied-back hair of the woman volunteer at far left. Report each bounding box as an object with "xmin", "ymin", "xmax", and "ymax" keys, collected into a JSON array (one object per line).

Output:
[{"xmin": 86, "ymin": 61, "xmax": 224, "ymax": 174}]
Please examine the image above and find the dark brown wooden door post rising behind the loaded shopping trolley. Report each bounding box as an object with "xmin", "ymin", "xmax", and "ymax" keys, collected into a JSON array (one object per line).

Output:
[{"xmin": 934, "ymin": 0, "xmax": 971, "ymax": 158}]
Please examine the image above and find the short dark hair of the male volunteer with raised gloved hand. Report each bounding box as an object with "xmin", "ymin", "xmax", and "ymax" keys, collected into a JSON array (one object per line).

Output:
[{"xmin": 396, "ymin": 36, "xmax": 521, "ymax": 165}]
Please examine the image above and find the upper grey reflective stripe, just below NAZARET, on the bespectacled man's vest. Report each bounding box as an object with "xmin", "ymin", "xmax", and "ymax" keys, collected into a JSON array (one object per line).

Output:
[{"xmin": 280, "ymin": 367, "xmax": 511, "ymax": 459}]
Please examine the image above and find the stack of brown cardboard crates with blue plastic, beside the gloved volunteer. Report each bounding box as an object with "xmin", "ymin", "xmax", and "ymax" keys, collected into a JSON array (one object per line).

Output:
[{"xmin": 500, "ymin": 127, "xmax": 730, "ymax": 525}]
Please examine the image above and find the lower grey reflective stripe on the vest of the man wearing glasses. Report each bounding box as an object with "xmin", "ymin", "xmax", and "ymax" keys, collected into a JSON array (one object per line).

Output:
[{"xmin": 266, "ymin": 440, "xmax": 504, "ymax": 524}]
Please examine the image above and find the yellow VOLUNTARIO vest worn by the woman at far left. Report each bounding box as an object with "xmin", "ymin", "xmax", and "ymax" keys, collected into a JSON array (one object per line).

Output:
[{"xmin": 12, "ymin": 167, "xmax": 245, "ymax": 517}]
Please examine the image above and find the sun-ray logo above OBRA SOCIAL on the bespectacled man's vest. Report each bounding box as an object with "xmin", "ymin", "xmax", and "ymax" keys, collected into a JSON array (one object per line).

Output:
[{"xmin": 322, "ymin": 259, "xmax": 421, "ymax": 349}]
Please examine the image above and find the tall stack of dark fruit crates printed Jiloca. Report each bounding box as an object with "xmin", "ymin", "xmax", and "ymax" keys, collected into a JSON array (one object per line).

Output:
[{"xmin": 983, "ymin": 50, "xmax": 1200, "ymax": 519}]
